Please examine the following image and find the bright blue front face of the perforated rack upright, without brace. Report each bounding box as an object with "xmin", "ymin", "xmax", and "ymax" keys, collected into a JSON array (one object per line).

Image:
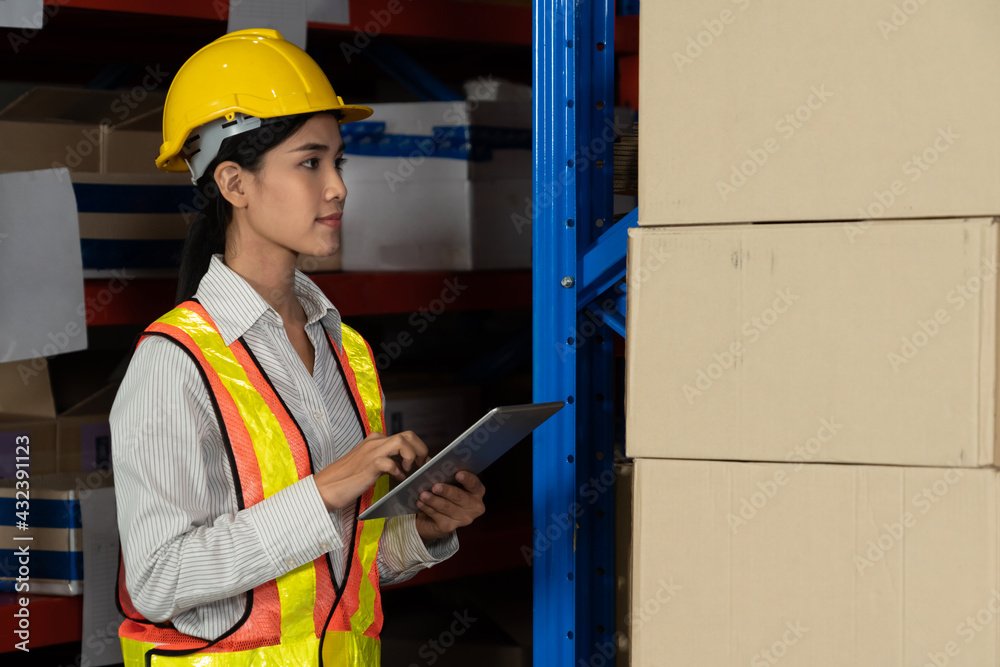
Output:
[{"xmin": 532, "ymin": 0, "xmax": 579, "ymax": 667}]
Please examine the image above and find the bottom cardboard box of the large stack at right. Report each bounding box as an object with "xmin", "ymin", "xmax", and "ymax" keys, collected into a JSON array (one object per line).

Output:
[{"xmin": 631, "ymin": 459, "xmax": 1000, "ymax": 667}]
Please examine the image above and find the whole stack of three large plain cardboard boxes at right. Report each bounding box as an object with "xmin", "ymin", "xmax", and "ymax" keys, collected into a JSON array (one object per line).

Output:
[{"xmin": 626, "ymin": 0, "xmax": 1000, "ymax": 667}]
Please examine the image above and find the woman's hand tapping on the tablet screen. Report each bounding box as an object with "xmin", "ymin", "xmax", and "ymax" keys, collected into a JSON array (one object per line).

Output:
[{"xmin": 313, "ymin": 431, "xmax": 427, "ymax": 511}]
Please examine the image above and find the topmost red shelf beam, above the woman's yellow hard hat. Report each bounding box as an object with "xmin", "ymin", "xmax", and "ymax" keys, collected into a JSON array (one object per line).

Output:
[{"xmin": 45, "ymin": 0, "xmax": 531, "ymax": 45}]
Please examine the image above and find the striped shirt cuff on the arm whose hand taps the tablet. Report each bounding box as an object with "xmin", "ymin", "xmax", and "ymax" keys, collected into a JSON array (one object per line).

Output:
[{"xmin": 247, "ymin": 475, "xmax": 343, "ymax": 576}]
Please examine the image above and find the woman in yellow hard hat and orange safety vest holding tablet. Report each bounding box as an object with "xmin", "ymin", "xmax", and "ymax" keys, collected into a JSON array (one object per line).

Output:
[{"xmin": 110, "ymin": 30, "xmax": 485, "ymax": 667}]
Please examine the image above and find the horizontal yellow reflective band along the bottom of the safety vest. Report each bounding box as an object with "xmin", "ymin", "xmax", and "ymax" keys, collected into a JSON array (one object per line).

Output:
[{"xmin": 120, "ymin": 632, "xmax": 381, "ymax": 667}]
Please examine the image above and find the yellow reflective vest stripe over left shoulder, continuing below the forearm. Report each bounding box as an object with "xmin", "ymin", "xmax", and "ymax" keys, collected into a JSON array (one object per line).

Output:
[{"xmin": 157, "ymin": 308, "xmax": 316, "ymax": 643}]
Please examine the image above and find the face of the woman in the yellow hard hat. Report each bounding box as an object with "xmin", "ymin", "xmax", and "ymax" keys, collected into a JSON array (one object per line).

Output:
[{"xmin": 234, "ymin": 114, "xmax": 347, "ymax": 256}]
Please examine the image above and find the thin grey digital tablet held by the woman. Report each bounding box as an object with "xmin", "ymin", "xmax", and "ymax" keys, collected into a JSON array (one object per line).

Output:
[{"xmin": 358, "ymin": 401, "xmax": 566, "ymax": 521}]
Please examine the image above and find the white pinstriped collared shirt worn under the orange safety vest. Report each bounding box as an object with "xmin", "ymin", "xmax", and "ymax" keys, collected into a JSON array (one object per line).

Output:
[{"xmin": 110, "ymin": 253, "xmax": 458, "ymax": 639}]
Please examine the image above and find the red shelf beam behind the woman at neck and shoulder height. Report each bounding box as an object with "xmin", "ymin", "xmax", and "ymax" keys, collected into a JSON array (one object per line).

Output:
[{"xmin": 83, "ymin": 270, "xmax": 531, "ymax": 326}]
